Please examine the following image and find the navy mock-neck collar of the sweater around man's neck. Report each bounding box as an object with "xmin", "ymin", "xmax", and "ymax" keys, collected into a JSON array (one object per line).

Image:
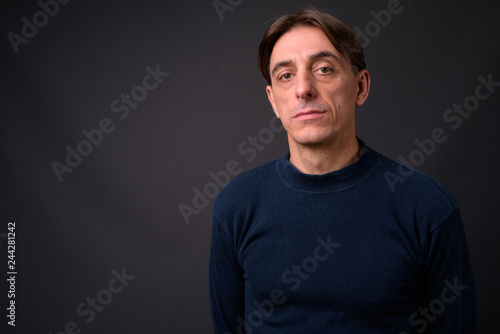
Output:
[{"xmin": 277, "ymin": 138, "xmax": 379, "ymax": 193}]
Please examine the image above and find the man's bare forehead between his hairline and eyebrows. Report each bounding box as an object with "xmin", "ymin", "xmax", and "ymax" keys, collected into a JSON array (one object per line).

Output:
[{"xmin": 270, "ymin": 26, "xmax": 343, "ymax": 68}]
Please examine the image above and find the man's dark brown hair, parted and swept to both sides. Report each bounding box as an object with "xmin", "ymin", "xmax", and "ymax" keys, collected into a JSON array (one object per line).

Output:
[{"xmin": 257, "ymin": 8, "xmax": 366, "ymax": 84}]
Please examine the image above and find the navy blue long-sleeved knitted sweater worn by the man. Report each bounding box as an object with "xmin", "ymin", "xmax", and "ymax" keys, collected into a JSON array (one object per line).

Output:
[{"xmin": 209, "ymin": 141, "xmax": 477, "ymax": 334}]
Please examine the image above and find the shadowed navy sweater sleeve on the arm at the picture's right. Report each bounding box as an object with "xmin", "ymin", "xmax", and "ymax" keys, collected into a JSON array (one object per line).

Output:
[{"xmin": 410, "ymin": 208, "xmax": 477, "ymax": 334}]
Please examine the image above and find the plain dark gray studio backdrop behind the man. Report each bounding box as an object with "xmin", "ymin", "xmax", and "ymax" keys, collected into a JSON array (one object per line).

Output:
[{"xmin": 0, "ymin": 0, "xmax": 500, "ymax": 334}]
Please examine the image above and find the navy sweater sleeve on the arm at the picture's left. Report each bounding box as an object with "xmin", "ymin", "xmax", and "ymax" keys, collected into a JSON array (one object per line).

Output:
[{"xmin": 209, "ymin": 215, "xmax": 245, "ymax": 334}]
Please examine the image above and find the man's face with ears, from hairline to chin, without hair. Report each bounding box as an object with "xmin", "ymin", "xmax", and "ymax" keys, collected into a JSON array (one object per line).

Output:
[{"xmin": 266, "ymin": 26, "xmax": 370, "ymax": 146}]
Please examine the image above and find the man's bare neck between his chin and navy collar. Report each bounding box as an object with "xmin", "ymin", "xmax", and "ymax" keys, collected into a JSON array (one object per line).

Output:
[{"xmin": 289, "ymin": 136, "xmax": 362, "ymax": 174}]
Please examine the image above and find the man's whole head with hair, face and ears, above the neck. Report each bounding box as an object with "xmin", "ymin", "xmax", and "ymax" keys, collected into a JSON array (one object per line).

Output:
[{"xmin": 258, "ymin": 9, "xmax": 370, "ymax": 149}]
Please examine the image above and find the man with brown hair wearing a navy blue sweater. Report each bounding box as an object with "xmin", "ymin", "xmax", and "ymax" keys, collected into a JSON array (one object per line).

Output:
[{"xmin": 209, "ymin": 10, "xmax": 477, "ymax": 334}]
